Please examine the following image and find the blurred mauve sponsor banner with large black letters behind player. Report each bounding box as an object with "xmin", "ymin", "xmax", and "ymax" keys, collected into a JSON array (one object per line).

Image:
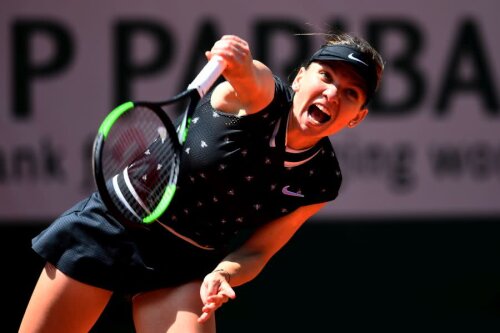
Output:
[{"xmin": 0, "ymin": 0, "xmax": 500, "ymax": 221}]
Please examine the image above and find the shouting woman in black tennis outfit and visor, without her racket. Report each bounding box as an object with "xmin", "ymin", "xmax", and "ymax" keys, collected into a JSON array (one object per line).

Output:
[{"xmin": 20, "ymin": 34, "xmax": 383, "ymax": 333}]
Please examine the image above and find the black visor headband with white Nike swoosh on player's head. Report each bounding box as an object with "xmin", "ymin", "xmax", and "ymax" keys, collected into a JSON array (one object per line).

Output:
[{"xmin": 309, "ymin": 45, "xmax": 377, "ymax": 104}]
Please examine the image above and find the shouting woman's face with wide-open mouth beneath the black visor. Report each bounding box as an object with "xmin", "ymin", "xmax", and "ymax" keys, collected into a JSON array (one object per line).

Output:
[{"xmin": 289, "ymin": 61, "xmax": 368, "ymax": 148}]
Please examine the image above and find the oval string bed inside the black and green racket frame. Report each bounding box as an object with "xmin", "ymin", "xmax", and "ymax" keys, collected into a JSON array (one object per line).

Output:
[{"xmin": 102, "ymin": 107, "xmax": 179, "ymax": 221}]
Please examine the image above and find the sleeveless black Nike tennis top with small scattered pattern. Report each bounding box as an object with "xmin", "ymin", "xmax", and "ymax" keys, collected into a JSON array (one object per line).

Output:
[{"xmin": 146, "ymin": 78, "xmax": 342, "ymax": 248}]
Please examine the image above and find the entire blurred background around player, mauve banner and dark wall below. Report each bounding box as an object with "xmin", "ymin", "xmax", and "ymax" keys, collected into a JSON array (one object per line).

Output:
[{"xmin": 0, "ymin": 0, "xmax": 500, "ymax": 332}]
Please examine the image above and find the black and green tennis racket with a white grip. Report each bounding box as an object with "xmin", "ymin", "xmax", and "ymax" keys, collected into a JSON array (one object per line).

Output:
[{"xmin": 92, "ymin": 56, "xmax": 226, "ymax": 223}]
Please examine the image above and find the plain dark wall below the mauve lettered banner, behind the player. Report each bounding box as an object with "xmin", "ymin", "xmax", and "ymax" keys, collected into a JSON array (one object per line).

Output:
[{"xmin": 4, "ymin": 217, "xmax": 500, "ymax": 333}]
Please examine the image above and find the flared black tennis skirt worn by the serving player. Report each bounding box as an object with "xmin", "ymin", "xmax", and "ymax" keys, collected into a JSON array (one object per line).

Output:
[{"xmin": 32, "ymin": 193, "xmax": 225, "ymax": 294}]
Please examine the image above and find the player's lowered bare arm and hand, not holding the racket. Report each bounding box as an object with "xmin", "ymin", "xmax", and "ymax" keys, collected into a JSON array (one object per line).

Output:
[{"xmin": 198, "ymin": 203, "xmax": 325, "ymax": 322}]
